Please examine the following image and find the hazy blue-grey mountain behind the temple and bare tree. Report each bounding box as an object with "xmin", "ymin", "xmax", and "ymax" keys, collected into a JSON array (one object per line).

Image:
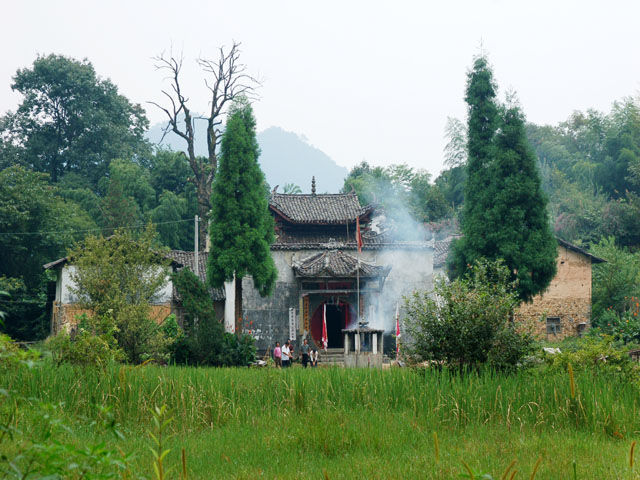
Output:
[{"xmin": 147, "ymin": 122, "xmax": 349, "ymax": 193}]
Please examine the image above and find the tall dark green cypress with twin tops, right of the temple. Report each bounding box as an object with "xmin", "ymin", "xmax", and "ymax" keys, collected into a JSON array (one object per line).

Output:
[{"xmin": 449, "ymin": 58, "xmax": 557, "ymax": 301}]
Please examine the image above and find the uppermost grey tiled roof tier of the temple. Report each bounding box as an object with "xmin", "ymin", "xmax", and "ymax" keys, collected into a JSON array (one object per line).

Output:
[{"xmin": 269, "ymin": 193, "xmax": 373, "ymax": 225}]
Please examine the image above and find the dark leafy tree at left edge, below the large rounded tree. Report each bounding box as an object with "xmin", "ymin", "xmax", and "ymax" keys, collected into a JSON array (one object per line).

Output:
[{"xmin": 0, "ymin": 165, "xmax": 96, "ymax": 340}]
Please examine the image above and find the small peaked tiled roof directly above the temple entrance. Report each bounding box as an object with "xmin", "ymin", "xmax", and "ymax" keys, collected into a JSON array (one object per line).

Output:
[{"xmin": 293, "ymin": 250, "xmax": 391, "ymax": 278}]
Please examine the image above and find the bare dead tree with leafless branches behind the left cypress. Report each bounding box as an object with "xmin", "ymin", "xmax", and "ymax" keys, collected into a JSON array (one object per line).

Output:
[{"xmin": 149, "ymin": 42, "xmax": 260, "ymax": 248}]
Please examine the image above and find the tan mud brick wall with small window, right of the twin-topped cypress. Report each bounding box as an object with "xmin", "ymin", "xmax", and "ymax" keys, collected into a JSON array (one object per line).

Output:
[{"xmin": 515, "ymin": 246, "xmax": 591, "ymax": 340}]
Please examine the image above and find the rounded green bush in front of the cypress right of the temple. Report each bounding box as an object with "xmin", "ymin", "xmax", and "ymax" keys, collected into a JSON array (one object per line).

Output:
[{"xmin": 405, "ymin": 260, "xmax": 532, "ymax": 369}]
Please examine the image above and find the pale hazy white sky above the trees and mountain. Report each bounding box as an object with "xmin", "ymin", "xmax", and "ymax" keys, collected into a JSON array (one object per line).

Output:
[{"xmin": 0, "ymin": 0, "xmax": 640, "ymax": 174}]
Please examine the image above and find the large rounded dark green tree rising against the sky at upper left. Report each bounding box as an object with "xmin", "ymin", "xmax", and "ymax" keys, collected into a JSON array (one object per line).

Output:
[{"xmin": 0, "ymin": 55, "xmax": 148, "ymax": 185}]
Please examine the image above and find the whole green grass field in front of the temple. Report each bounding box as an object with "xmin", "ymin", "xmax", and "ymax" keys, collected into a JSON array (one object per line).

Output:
[{"xmin": 0, "ymin": 362, "xmax": 640, "ymax": 479}]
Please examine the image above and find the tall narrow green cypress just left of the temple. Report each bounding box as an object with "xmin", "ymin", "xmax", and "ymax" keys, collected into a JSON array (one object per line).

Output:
[{"xmin": 207, "ymin": 100, "xmax": 277, "ymax": 318}]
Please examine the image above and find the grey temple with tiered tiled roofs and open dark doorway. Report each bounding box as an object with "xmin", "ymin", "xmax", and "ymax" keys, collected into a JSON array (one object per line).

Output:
[{"xmin": 231, "ymin": 188, "xmax": 433, "ymax": 354}]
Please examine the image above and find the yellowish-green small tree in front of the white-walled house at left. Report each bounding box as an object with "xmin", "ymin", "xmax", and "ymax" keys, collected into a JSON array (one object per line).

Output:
[{"xmin": 69, "ymin": 226, "xmax": 168, "ymax": 363}]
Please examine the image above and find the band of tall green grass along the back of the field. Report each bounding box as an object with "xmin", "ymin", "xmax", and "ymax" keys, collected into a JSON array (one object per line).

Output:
[{"xmin": 0, "ymin": 363, "xmax": 640, "ymax": 438}]
